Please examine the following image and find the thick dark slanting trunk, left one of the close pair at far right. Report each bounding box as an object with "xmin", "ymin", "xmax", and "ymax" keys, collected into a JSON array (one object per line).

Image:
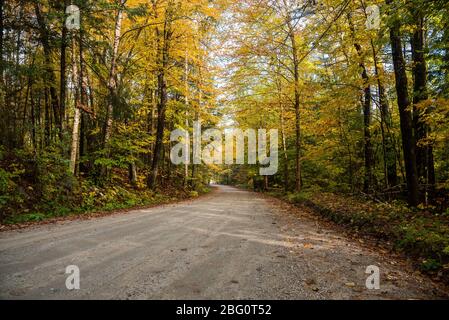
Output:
[{"xmin": 387, "ymin": 0, "xmax": 419, "ymax": 206}]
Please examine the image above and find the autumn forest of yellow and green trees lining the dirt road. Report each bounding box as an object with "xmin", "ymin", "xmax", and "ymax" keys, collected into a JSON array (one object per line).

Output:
[{"xmin": 0, "ymin": 0, "xmax": 449, "ymax": 276}]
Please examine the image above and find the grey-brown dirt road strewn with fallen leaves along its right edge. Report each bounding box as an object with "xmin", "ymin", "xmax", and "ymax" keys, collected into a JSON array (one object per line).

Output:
[{"xmin": 0, "ymin": 186, "xmax": 442, "ymax": 299}]
